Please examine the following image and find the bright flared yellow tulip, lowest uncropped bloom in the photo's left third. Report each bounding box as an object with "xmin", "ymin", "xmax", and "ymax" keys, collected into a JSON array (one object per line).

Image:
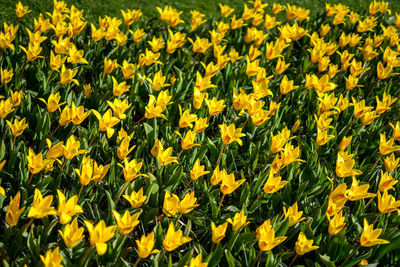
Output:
[{"xmin": 84, "ymin": 220, "xmax": 117, "ymax": 256}]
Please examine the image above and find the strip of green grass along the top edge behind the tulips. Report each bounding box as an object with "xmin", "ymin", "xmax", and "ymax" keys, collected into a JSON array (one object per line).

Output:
[{"xmin": 0, "ymin": 0, "xmax": 400, "ymax": 22}]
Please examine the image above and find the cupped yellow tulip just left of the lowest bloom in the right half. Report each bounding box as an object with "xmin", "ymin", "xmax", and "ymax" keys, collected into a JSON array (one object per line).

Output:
[{"xmin": 256, "ymin": 219, "xmax": 287, "ymax": 251}]
